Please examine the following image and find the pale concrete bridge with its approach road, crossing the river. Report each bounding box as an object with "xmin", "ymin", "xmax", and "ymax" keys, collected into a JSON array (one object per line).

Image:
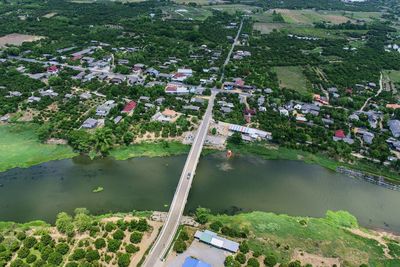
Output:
[{"xmin": 143, "ymin": 92, "xmax": 217, "ymax": 267}]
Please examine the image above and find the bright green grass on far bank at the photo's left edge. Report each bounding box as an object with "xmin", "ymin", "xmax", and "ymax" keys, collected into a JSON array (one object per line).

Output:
[{"xmin": 0, "ymin": 123, "xmax": 77, "ymax": 171}]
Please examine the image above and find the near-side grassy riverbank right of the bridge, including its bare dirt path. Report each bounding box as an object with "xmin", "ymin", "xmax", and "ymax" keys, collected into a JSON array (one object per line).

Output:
[{"xmin": 209, "ymin": 211, "xmax": 400, "ymax": 266}]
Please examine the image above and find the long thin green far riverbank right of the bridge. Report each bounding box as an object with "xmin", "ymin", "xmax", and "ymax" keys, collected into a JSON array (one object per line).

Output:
[{"xmin": 227, "ymin": 143, "xmax": 400, "ymax": 184}]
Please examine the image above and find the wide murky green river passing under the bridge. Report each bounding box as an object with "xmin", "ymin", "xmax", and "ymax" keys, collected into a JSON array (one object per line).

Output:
[{"xmin": 0, "ymin": 153, "xmax": 400, "ymax": 232}]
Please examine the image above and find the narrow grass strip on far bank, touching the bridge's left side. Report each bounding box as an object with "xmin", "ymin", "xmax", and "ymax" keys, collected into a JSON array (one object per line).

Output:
[{"xmin": 110, "ymin": 142, "xmax": 190, "ymax": 160}]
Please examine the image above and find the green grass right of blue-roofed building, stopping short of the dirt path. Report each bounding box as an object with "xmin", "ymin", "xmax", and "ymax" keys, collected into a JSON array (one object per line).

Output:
[{"xmin": 210, "ymin": 211, "xmax": 385, "ymax": 266}]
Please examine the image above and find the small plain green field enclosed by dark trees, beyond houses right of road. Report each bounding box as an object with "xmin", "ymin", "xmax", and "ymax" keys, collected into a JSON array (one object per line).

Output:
[{"xmin": 273, "ymin": 66, "xmax": 311, "ymax": 94}]
